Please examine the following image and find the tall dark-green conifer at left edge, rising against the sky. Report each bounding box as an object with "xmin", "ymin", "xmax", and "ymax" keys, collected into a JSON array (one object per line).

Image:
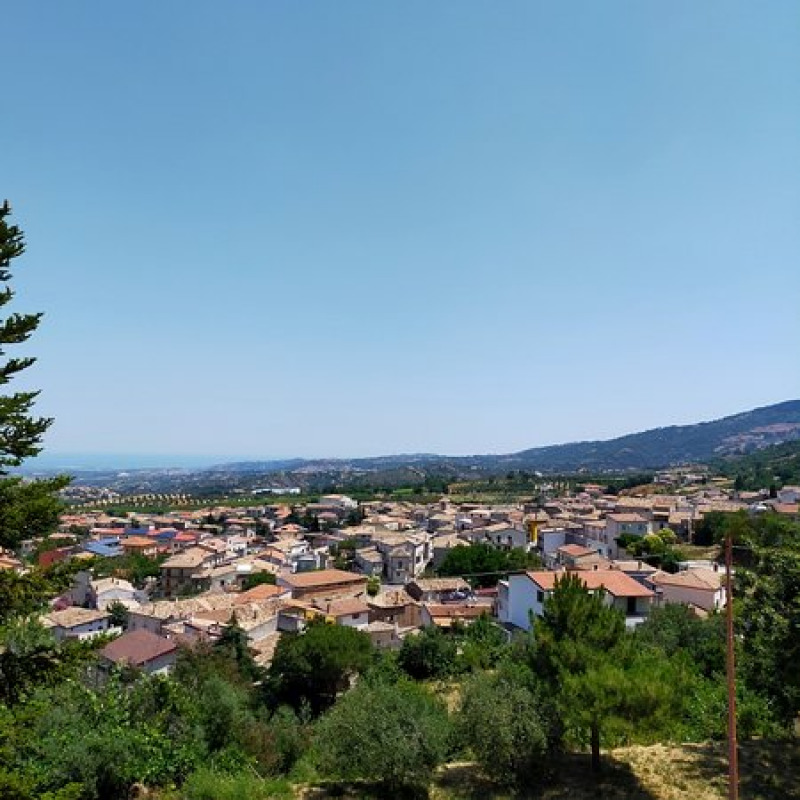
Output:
[{"xmin": 0, "ymin": 202, "xmax": 69, "ymax": 549}]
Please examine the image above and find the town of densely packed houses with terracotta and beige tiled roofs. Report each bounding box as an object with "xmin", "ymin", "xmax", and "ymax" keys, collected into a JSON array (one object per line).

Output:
[{"xmin": 0, "ymin": 476, "xmax": 800, "ymax": 671}]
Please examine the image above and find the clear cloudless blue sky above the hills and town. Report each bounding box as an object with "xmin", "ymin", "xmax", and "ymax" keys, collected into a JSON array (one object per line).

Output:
[{"xmin": 0, "ymin": 0, "xmax": 800, "ymax": 457}]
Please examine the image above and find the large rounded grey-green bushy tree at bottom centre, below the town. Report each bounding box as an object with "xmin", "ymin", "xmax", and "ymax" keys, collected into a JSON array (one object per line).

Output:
[{"xmin": 315, "ymin": 680, "xmax": 451, "ymax": 797}]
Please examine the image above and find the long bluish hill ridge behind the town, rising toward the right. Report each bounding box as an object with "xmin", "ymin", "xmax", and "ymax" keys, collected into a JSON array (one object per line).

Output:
[{"xmin": 40, "ymin": 400, "xmax": 800, "ymax": 496}]
